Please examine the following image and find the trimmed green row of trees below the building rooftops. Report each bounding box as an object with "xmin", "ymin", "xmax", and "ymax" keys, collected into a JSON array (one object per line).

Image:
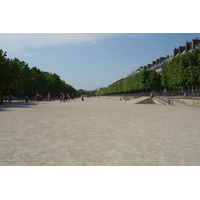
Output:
[{"xmin": 96, "ymin": 48, "xmax": 200, "ymax": 95}]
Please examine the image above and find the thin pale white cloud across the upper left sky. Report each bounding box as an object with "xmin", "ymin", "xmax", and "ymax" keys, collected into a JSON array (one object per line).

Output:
[{"xmin": 0, "ymin": 33, "xmax": 119, "ymax": 52}]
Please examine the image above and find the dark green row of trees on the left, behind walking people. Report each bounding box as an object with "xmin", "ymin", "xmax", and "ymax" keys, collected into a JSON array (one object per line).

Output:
[{"xmin": 0, "ymin": 49, "xmax": 77, "ymax": 97}]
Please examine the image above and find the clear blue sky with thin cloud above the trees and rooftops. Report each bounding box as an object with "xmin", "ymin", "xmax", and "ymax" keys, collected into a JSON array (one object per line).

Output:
[{"xmin": 0, "ymin": 33, "xmax": 200, "ymax": 90}]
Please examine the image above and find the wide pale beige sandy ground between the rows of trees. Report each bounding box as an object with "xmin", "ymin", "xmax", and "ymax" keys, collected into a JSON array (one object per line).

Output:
[{"xmin": 0, "ymin": 98, "xmax": 200, "ymax": 166}]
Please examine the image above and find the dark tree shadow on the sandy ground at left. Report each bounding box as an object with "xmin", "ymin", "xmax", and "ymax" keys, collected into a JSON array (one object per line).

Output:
[{"xmin": 0, "ymin": 101, "xmax": 38, "ymax": 112}]
